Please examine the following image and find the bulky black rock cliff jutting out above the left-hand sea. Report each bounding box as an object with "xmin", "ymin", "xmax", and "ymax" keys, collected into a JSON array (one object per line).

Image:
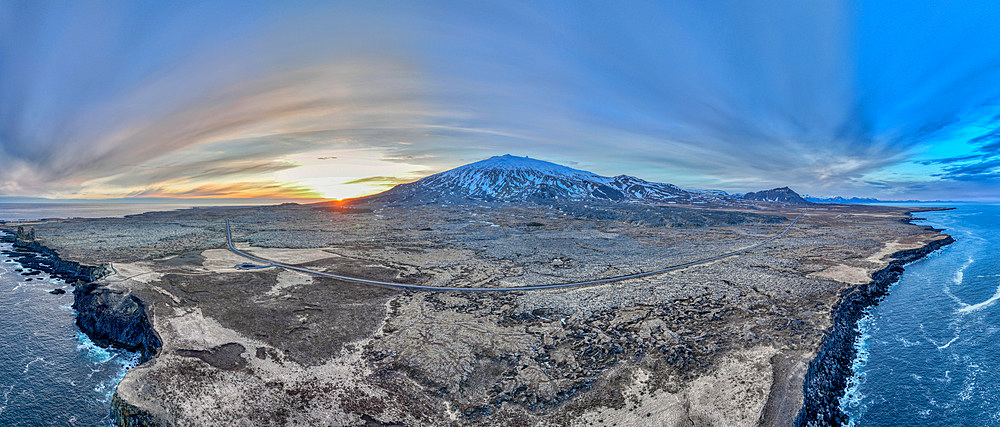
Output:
[{"xmin": 73, "ymin": 283, "xmax": 161, "ymax": 361}]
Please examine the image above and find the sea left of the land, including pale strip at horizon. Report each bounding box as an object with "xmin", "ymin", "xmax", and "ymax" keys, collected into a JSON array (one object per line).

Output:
[{"xmin": 0, "ymin": 203, "xmax": 209, "ymax": 427}]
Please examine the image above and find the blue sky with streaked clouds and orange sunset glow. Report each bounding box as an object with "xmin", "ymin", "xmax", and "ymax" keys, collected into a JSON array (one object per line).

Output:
[{"xmin": 0, "ymin": 0, "xmax": 1000, "ymax": 201}]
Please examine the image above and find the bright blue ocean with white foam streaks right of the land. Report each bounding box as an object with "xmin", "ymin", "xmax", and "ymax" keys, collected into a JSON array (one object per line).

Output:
[{"xmin": 841, "ymin": 205, "xmax": 1000, "ymax": 426}]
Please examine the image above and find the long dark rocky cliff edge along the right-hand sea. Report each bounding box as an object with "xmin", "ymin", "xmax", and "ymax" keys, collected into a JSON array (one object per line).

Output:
[{"xmin": 795, "ymin": 212, "xmax": 955, "ymax": 426}]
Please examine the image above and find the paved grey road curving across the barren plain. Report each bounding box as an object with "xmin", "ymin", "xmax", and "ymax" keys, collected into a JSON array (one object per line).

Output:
[{"xmin": 226, "ymin": 211, "xmax": 806, "ymax": 292}]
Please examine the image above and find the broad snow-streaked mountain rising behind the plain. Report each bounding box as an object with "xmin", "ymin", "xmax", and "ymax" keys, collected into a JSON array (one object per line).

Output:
[{"xmin": 372, "ymin": 154, "xmax": 727, "ymax": 203}]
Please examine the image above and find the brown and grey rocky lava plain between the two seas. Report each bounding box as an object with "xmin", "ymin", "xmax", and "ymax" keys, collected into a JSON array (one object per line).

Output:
[{"xmin": 4, "ymin": 199, "xmax": 946, "ymax": 426}]
